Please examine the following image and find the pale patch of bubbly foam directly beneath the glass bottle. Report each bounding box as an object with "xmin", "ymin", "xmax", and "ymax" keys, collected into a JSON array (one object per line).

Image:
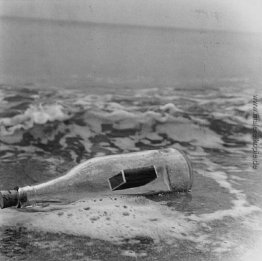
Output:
[{"xmin": 1, "ymin": 197, "xmax": 198, "ymax": 242}]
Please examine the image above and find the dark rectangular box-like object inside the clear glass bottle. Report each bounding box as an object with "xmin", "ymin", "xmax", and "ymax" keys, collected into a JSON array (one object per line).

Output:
[{"xmin": 108, "ymin": 166, "xmax": 157, "ymax": 191}]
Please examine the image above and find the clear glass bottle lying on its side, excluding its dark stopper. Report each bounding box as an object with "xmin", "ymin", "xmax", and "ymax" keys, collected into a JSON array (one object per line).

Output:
[{"xmin": 0, "ymin": 148, "xmax": 193, "ymax": 205}]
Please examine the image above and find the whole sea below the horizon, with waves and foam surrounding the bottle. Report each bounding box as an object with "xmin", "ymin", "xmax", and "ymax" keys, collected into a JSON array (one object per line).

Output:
[{"xmin": 0, "ymin": 18, "xmax": 262, "ymax": 260}]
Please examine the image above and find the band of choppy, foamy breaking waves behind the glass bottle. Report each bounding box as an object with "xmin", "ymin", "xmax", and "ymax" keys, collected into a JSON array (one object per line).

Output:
[{"xmin": 0, "ymin": 81, "xmax": 261, "ymax": 161}]
